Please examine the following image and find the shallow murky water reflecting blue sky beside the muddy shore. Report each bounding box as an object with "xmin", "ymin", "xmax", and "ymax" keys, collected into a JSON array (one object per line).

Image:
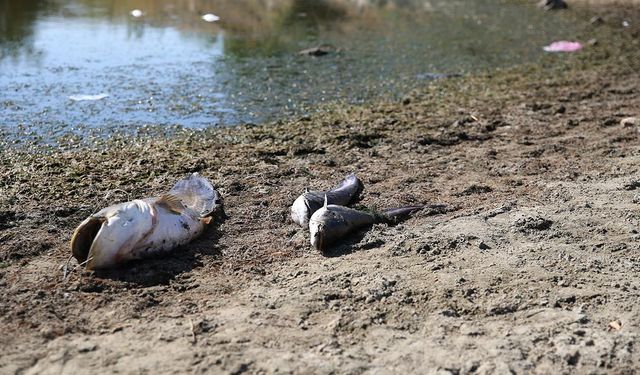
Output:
[{"xmin": 0, "ymin": 0, "xmax": 575, "ymax": 145}]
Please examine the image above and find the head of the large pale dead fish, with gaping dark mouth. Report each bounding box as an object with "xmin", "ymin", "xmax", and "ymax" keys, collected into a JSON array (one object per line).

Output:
[{"xmin": 71, "ymin": 200, "xmax": 156, "ymax": 270}]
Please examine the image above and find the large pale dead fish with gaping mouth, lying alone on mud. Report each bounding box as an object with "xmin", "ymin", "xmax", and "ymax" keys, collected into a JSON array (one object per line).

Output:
[{"xmin": 71, "ymin": 173, "xmax": 221, "ymax": 270}]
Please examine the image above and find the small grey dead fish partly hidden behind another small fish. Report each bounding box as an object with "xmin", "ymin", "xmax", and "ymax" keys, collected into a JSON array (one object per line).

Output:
[{"xmin": 291, "ymin": 174, "xmax": 364, "ymax": 227}]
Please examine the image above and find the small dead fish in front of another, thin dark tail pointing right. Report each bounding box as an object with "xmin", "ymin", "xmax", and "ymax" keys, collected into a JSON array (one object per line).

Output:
[{"xmin": 309, "ymin": 203, "xmax": 425, "ymax": 251}]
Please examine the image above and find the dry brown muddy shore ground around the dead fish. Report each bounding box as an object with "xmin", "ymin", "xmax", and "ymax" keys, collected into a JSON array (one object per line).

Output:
[{"xmin": 0, "ymin": 1, "xmax": 640, "ymax": 374}]
